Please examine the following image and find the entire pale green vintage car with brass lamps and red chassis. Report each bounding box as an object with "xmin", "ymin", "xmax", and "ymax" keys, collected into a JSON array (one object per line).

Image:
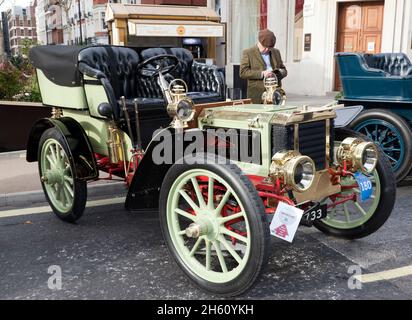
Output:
[{"xmin": 27, "ymin": 46, "xmax": 396, "ymax": 296}]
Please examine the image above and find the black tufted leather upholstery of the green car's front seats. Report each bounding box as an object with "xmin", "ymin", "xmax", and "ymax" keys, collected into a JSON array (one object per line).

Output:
[{"xmin": 79, "ymin": 46, "xmax": 224, "ymax": 105}]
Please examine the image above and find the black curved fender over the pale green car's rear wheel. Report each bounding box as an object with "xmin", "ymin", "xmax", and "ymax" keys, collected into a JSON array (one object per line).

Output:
[{"xmin": 26, "ymin": 117, "xmax": 99, "ymax": 181}]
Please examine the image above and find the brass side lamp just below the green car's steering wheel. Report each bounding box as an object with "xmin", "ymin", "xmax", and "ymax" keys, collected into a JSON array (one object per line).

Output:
[{"xmin": 167, "ymin": 79, "xmax": 195, "ymax": 128}]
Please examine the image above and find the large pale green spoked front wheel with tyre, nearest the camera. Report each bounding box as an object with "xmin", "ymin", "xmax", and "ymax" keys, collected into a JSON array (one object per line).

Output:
[{"xmin": 160, "ymin": 154, "xmax": 269, "ymax": 296}]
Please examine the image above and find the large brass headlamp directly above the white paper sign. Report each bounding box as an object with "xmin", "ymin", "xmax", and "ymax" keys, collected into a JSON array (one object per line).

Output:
[{"xmin": 270, "ymin": 151, "xmax": 316, "ymax": 192}]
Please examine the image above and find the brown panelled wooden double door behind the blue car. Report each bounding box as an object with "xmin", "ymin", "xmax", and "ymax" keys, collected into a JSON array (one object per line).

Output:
[{"xmin": 335, "ymin": 1, "xmax": 385, "ymax": 91}]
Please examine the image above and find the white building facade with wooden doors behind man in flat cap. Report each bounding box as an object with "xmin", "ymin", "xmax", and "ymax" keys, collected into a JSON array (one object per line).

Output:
[{"xmin": 216, "ymin": 0, "xmax": 412, "ymax": 96}]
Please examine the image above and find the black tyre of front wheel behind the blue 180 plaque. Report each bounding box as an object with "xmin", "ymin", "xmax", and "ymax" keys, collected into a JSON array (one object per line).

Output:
[{"xmin": 314, "ymin": 129, "xmax": 396, "ymax": 240}]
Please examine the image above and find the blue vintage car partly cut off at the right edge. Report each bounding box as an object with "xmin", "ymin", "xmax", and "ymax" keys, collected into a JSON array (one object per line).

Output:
[{"xmin": 336, "ymin": 53, "xmax": 412, "ymax": 182}]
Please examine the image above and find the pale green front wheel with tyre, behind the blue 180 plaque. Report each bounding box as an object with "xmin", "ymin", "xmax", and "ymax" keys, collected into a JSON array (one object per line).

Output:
[{"xmin": 315, "ymin": 129, "xmax": 396, "ymax": 239}]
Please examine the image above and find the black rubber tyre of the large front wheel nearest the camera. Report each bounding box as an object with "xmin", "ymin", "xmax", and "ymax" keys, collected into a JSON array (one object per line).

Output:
[{"xmin": 159, "ymin": 154, "xmax": 270, "ymax": 297}]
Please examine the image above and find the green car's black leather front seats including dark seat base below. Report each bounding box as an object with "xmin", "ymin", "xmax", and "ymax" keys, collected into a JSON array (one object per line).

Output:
[{"xmin": 78, "ymin": 46, "xmax": 224, "ymax": 147}]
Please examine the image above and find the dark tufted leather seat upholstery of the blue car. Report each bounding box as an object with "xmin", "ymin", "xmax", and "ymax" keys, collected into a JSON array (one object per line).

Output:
[{"xmin": 364, "ymin": 53, "xmax": 412, "ymax": 77}]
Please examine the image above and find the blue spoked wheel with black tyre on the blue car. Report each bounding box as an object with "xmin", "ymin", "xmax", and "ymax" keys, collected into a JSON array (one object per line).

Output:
[{"xmin": 351, "ymin": 110, "xmax": 412, "ymax": 182}]
